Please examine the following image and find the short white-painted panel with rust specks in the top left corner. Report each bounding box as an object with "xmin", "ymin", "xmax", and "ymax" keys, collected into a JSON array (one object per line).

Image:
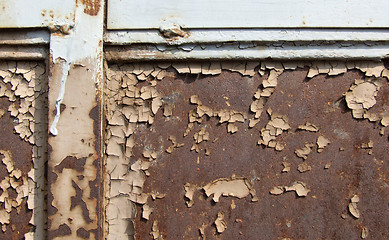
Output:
[{"xmin": 0, "ymin": 0, "xmax": 76, "ymax": 28}]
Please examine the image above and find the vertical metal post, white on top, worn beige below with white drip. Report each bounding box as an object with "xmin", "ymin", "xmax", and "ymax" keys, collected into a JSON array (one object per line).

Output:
[{"xmin": 47, "ymin": 0, "xmax": 104, "ymax": 239}]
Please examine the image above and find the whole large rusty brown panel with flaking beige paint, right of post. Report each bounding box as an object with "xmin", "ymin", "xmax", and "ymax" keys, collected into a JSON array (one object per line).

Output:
[{"xmin": 105, "ymin": 62, "xmax": 389, "ymax": 239}]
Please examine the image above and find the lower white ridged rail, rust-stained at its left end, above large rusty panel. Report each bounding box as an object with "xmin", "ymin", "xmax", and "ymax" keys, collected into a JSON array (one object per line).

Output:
[{"xmin": 105, "ymin": 44, "xmax": 389, "ymax": 62}]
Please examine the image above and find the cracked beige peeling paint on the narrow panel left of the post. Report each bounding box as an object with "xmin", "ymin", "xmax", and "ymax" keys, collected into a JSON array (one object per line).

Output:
[{"xmin": 0, "ymin": 61, "xmax": 47, "ymax": 239}]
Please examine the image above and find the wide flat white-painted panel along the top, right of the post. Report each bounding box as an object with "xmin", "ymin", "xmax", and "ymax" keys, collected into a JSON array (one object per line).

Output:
[{"xmin": 107, "ymin": 0, "xmax": 389, "ymax": 29}]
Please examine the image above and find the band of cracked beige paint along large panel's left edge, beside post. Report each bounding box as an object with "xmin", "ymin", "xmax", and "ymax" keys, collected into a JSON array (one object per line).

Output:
[{"xmin": 105, "ymin": 62, "xmax": 163, "ymax": 239}]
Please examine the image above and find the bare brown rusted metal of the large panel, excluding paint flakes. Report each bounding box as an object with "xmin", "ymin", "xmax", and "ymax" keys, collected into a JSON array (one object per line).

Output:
[{"xmin": 121, "ymin": 66, "xmax": 389, "ymax": 239}]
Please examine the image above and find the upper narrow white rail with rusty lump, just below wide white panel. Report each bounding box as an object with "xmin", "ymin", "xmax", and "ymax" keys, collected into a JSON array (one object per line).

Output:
[{"xmin": 104, "ymin": 29, "xmax": 389, "ymax": 45}]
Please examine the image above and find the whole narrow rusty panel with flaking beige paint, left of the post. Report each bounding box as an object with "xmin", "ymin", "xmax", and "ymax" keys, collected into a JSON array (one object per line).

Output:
[{"xmin": 0, "ymin": 61, "xmax": 47, "ymax": 239}]
